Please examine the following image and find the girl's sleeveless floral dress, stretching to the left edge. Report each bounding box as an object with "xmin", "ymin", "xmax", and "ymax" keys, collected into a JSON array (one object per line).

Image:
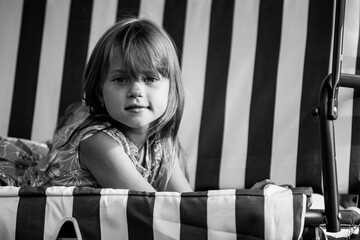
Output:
[{"xmin": 0, "ymin": 105, "xmax": 174, "ymax": 191}]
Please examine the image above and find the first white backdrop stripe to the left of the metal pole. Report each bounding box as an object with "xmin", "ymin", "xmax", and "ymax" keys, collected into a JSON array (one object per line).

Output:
[{"xmin": 270, "ymin": 0, "xmax": 309, "ymax": 185}]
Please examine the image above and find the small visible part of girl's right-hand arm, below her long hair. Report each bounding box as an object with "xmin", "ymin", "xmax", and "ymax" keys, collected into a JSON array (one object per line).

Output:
[{"xmin": 166, "ymin": 159, "xmax": 193, "ymax": 192}]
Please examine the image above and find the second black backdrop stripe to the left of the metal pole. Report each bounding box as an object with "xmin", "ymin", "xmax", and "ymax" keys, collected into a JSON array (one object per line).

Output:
[{"xmin": 245, "ymin": 0, "xmax": 283, "ymax": 188}]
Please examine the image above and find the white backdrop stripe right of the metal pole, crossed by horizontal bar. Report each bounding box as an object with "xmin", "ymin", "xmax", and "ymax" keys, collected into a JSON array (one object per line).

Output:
[{"xmin": 334, "ymin": 0, "xmax": 360, "ymax": 193}]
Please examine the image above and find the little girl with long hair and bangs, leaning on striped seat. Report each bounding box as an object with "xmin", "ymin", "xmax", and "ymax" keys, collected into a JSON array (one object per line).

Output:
[{"xmin": 33, "ymin": 18, "xmax": 192, "ymax": 192}]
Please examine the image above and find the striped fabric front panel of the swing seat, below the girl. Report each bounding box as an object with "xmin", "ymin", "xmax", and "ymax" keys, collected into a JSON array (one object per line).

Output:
[{"xmin": 0, "ymin": 185, "xmax": 306, "ymax": 240}]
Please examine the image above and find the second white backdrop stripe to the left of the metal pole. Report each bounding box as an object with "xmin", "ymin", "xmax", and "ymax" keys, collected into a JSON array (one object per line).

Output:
[{"xmin": 220, "ymin": 0, "xmax": 260, "ymax": 188}]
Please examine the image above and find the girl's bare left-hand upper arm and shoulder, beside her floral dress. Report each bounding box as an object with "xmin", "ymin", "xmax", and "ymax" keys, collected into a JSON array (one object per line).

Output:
[{"xmin": 79, "ymin": 132, "xmax": 155, "ymax": 192}]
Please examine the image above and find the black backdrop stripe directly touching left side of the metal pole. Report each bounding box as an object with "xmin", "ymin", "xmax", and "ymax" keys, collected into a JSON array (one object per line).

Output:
[{"xmin": 296, "ymin": 0, "xmax": 333, "ymax": 193}]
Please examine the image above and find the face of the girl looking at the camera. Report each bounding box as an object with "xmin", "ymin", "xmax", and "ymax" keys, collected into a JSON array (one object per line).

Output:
[{"xmin": 102, "ymin": 51, "xmax": 170, "ymax": 131}]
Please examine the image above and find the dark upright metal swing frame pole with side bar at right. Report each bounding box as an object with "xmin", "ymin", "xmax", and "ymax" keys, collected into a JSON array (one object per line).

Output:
[{"xmin": 316, "ymin": 0, "xmax": 360, "ymax": 232}]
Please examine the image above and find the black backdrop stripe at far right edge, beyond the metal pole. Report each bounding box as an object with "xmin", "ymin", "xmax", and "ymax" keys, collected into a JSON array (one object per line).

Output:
[{"xmin": 348, "ymin": 36, "xmax": 360, "ymax": 193}]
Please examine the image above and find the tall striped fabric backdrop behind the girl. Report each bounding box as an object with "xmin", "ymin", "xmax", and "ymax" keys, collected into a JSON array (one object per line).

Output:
[{"xmin": 0, "ymin": 0, "xmax": 360, "ymax": 193}]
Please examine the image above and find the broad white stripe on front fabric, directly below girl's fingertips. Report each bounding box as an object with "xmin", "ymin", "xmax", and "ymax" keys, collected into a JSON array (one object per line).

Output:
[{"xmin": 264, "ymin": 184, "xmax": 294, "ymax": 240}]
